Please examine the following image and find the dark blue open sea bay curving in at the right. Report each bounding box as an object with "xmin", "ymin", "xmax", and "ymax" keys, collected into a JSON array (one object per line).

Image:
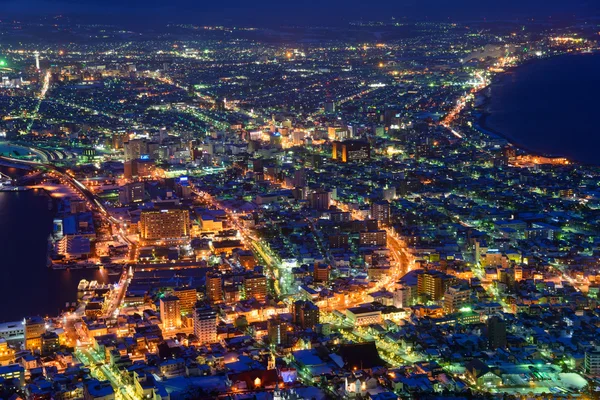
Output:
[{"xmin": 484, "ymin": 53, "xmax": 600, "ymax": 165}]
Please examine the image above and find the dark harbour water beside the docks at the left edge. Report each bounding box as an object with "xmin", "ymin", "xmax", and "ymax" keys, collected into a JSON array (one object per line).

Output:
[{"xmin": 0, "ymin": 177, "xmax": 112, "ymax": 322}]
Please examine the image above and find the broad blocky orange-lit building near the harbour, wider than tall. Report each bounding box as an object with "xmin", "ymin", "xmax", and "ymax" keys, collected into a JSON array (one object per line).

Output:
[{"xmin": 140, "ymin": 208, "xmax": 190, "ymax": 242}]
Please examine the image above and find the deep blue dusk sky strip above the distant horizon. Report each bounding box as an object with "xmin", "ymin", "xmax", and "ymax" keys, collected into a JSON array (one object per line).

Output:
[{"xmin": 0, "ymin": 0, "xmax": 600, "ymax": 25}]
